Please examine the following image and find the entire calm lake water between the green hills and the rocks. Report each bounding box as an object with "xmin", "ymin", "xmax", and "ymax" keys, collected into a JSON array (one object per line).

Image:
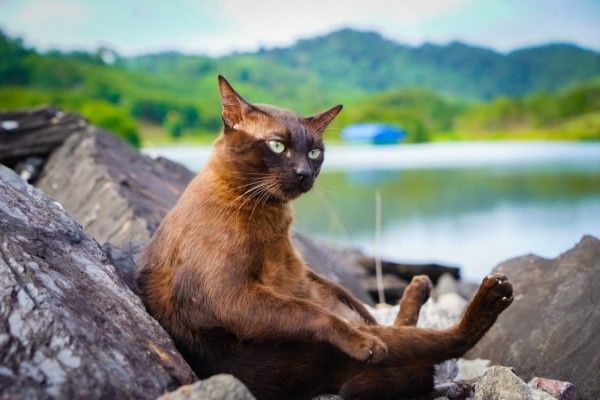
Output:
[{"xmin": 146, "ymin": 142, "xmax": 600, "ymax": 280}]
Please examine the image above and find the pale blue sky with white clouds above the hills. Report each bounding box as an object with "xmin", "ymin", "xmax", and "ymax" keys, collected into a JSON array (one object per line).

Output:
[{"xmin": 0, "ymin": 0, "xmax": 600, "ymax": 55}]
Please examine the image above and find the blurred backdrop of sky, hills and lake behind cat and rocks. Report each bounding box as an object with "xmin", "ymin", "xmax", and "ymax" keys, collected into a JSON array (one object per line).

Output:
[{"xmin": 0, "ymin": 0, "xmax": 600, "ymax": 279}]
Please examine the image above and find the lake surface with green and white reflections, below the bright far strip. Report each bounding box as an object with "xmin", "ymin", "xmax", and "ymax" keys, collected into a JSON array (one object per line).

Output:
[{"xmin": 295, "ymin": 162, "xmax": 600, "ymax": 279}]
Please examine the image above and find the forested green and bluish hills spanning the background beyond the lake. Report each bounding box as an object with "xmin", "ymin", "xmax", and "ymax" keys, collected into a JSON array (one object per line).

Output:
[{"xmin": 0, "ymin": 29, "xmax": 600, "ymax": 145}]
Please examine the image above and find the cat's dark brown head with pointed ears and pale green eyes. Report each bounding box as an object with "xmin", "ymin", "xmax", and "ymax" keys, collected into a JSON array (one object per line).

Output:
[{"xmin": 217, "ymin": 75, "xmax": 342, "ymax": 201}]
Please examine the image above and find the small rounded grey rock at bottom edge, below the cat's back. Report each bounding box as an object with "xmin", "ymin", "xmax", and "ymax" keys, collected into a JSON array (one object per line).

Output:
[{"xmin": 157, "ymin": 374, "xmax": 254, "ymax": 400}]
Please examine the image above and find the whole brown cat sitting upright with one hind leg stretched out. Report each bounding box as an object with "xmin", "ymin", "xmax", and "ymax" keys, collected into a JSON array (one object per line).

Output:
[{"xmin": 138, "ymin": 76, "xmax": 512, "ymax": 399}]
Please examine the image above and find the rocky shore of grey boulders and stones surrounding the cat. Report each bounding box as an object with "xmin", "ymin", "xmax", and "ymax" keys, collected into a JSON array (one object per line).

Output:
[{"xmin": 0, "ymin": 109, "xmax": 600, "ymax": 400}]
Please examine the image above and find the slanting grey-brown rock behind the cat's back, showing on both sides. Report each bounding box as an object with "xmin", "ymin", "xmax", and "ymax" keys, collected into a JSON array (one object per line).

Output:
[{"xmin": 37, "ymin": 123, "xmax": 372, "ymax": 303}]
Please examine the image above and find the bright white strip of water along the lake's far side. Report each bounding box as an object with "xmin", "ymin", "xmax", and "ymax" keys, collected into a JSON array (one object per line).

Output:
[{"xmin": 142, "ymin": 141, "xmax": 600, "ymax": 171}]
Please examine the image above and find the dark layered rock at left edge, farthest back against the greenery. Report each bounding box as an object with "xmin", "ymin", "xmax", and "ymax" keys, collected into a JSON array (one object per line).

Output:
[{"xmin": 0, "ymin": 107, "xmax": 89, "ymax": 168}]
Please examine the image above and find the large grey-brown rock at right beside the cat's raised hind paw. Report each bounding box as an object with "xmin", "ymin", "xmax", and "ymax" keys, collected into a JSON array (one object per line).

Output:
[{"xmin": 469, "ymin": 236, "xmax": 600, "ymax": 400}]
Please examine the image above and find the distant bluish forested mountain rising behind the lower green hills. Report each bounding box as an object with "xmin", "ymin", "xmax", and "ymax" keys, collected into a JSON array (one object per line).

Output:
[{"xmin": 254, "ymin": 29, "xmax": 600, "ymax": 99}]
